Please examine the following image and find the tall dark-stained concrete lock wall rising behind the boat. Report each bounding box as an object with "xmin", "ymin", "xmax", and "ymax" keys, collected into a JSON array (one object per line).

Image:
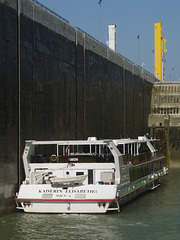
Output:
[{"xmin": 0, "ymin": 0, "xmax": 155, "ymax": 214}]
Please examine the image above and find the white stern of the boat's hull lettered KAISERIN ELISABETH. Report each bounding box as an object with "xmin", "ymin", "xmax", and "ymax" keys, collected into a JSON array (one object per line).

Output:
[{"xmin": 16, "ymin": 184, "xmax": 118, "ymax": 213}]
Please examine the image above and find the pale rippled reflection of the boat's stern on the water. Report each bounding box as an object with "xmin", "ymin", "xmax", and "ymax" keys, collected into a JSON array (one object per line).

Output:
[{"xmin": 12, "ymin": 214, "xmax": 122, "ymax": 240}]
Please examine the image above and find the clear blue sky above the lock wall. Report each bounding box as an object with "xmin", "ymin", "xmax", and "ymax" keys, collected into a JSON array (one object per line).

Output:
[{"xmin": 38, "ymin": 0, "xmax": 180, "ymax": 81}]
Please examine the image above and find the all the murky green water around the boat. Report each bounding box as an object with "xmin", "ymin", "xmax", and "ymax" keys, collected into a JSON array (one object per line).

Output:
[{"xmin": 0, "ymin": 168, "xmax": 180, "ymax": 240}]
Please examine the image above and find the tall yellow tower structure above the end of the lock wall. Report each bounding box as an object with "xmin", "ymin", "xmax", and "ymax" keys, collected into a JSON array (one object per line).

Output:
[{"xmin": 154, "ymin": 22, "xmax": 167, "ymax": 81}]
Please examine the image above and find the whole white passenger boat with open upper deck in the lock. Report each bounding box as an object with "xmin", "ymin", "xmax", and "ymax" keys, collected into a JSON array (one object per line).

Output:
[{"xmin": 15, "ymin": 136, "xmax": 168, "ymax": 213}]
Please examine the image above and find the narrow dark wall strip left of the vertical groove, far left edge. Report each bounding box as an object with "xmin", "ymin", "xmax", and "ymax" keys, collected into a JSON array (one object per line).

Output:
[{"xmin": 0, "ymin": 1, "xmax": 18, "ymax": 215}]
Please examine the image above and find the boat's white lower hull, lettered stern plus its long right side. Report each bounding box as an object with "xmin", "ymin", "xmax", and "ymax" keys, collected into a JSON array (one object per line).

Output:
[{"xmin": 15, "ymin": 173, "xmax": 166, "ymax": 213}]
